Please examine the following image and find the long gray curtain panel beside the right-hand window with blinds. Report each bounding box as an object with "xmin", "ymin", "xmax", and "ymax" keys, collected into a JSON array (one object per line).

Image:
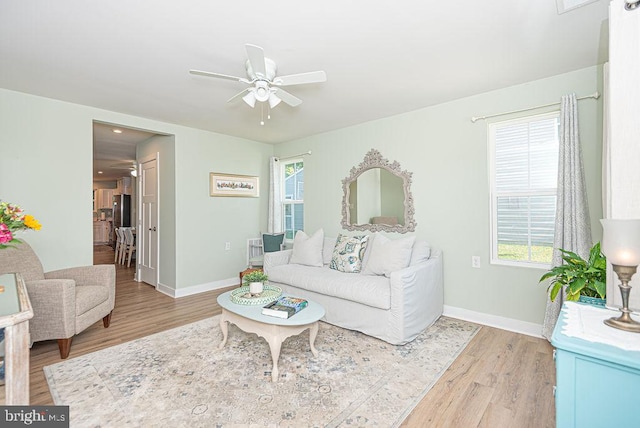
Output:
[{"xmin": 542, "ymin": 94, "xmax": 592, "ymax": 340}]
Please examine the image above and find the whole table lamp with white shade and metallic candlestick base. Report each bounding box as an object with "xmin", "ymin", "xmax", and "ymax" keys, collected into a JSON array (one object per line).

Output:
[{"xmin": 600, "ymin": 219, "xmax": 640, "ymax": 333}]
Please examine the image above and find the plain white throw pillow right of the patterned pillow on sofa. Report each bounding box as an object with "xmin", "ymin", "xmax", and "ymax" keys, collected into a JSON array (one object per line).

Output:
[{"xmin": 362, "ymin": 234, "xmax": 416, "ymax": 277}]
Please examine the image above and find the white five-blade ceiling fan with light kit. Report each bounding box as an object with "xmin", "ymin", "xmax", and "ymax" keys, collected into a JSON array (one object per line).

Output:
[{"xmin": 189, "ymin": 44, "xmax": 327, "ymax": 112}]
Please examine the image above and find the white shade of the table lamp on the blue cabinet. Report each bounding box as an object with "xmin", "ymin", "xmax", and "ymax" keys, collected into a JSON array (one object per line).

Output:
[{"xmin": 600, "ymin": 219, "xmax": 640, "ymax": 266}]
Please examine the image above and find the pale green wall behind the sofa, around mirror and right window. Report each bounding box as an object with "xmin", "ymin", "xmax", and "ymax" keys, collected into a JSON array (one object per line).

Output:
[{"xmin": 276, "ymin": 67, "xmax": 602, "ymax": 324}]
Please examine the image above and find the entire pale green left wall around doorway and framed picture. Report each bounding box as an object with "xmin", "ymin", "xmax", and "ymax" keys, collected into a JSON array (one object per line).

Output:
[{"xmin": 0, "ymin": 89, "xmax": 273, "ymax": 288}]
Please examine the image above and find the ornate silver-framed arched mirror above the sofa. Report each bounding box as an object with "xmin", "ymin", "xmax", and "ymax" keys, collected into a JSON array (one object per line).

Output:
[{"xmin": 342, "ymin": 149, "xmax": 416, "ymax": 233}]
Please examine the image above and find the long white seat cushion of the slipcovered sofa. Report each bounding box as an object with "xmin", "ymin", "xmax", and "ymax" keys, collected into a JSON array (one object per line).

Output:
[{"xmin": 269, "ymin": 264, "xmax": 391, "ymax": 310}]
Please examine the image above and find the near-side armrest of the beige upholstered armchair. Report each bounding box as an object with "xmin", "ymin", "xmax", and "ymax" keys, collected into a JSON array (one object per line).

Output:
[{"xmin": 25, "ymin": 279, "xmax": 76, "ymax": 342}]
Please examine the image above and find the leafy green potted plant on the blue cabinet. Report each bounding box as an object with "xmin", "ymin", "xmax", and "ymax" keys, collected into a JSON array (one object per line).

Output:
[{"xmin": 540, "ymin": 242, "xmax": 607, "ymax": 306}]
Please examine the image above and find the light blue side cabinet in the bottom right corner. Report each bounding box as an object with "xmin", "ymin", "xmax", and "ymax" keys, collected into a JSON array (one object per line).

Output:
[{"xmin": 551, "ymin": 308, "xmax": 640, "ymax": 428}]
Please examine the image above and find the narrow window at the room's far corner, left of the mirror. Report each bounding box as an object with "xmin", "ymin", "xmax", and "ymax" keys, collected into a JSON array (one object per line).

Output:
[{"xmin": 282, "ymin": 159, "xmax": 304, "ymax": 240}]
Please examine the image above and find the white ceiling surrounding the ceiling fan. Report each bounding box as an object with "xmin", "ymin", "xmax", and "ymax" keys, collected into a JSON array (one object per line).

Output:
[{"xmin": 0, "ymin": 0, "xmax": 608, "ymax": 154}]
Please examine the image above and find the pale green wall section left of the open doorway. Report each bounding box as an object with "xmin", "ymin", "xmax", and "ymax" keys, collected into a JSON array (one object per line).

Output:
[{"xmin": 0, "ymin": 89, "xmax": 93, "ymax": 270}]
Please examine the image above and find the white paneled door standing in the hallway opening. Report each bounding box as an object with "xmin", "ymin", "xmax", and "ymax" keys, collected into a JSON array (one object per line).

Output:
[{"xmin": 136, "ymin": 153, "xmax": 159, "ymax": 287}]
